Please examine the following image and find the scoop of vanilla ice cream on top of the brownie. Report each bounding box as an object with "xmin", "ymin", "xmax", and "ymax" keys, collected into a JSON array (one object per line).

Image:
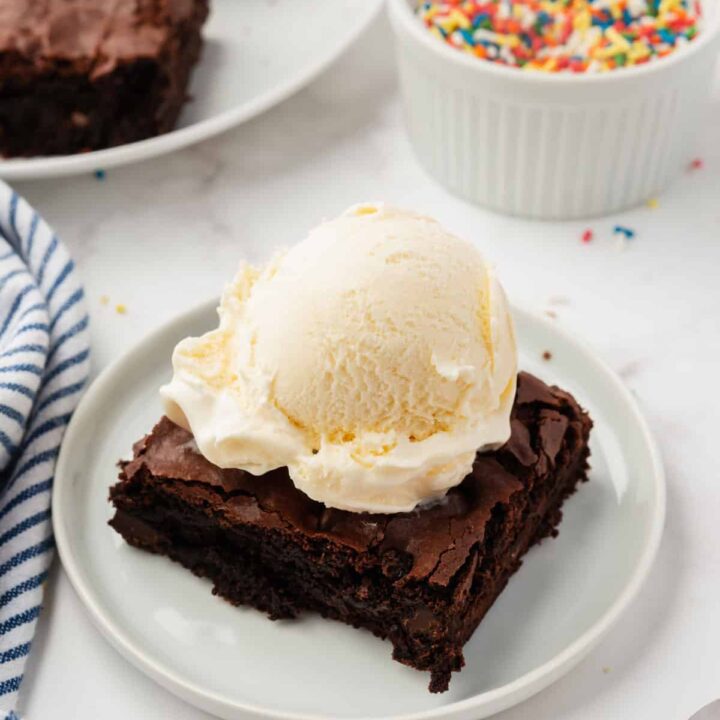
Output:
[{"xmin": 161, "ymin": 205, "xmax": 517, "ymax": 513}]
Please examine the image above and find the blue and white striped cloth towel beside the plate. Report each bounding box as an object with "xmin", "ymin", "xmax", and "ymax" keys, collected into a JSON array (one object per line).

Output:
[{"xmin": 0, "ymin": 182, "xmax": 90, "ymax": 720}]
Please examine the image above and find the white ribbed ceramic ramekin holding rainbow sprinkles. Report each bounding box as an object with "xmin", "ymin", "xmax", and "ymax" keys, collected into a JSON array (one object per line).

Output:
[{"xmin": 389, "ymin": 0, "xmax": 720, "ymax": 220}]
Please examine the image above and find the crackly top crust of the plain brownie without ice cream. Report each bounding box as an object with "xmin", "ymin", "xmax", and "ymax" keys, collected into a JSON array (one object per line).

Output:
[{"xmin": 0, "ymin": 0, "xmax": 207, "ymax": 77}]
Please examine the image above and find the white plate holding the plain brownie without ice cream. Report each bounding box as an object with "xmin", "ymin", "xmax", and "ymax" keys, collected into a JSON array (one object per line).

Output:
[{"xmin": 0, "ymin": 0, "xmax": 382, "ymax": 180}]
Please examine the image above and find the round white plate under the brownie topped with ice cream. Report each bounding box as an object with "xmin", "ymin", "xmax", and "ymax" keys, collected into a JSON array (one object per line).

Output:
[{"xmin": 53, "ymin": 304, "xmax": 665, "ymax": 720}]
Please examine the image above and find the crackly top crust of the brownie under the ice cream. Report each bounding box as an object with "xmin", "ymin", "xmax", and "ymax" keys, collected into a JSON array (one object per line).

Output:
[{"xmin": 121, "ymin": 373, "xmax": 591, "ymax": 586}]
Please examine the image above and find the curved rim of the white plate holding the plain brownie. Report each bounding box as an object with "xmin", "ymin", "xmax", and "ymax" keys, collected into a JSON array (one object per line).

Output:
[{"xmin": 0, "ymin": 0, "xmax": 384, "ymax": 180}]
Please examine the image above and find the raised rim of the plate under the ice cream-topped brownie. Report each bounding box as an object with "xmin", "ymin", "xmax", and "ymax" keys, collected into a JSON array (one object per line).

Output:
[{"xmin": 52, "ymin": 298, "xmax": 667, "ymax": 720}]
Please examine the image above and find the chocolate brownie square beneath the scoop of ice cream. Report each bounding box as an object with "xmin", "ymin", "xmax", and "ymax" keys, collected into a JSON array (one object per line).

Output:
[{"xmin": 110, "ymin": 373, "xmax": 592, "ymax": 692}]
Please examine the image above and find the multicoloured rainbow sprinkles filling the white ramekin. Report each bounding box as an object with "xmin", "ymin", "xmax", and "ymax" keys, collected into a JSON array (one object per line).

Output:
[{"xmin": 417, "ymin": 0, "xmax": 702, "ymax": 73}]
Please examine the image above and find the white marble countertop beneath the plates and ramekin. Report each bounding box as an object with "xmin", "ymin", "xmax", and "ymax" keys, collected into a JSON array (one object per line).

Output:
[{"xmin": 11, "ymin": 14, "xmax": 720, "ymax": 720}]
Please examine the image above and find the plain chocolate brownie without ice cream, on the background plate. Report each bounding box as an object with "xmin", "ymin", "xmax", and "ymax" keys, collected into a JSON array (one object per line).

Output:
[{"xmin": 0, "ymin": 0, "xmax": 208, "ymax": 156}]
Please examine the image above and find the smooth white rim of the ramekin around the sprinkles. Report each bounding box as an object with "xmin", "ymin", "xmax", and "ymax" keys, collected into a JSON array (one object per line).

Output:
[{"xmin": 387, "ymin": 0, "xmax": 720, "ymax": 86}]
